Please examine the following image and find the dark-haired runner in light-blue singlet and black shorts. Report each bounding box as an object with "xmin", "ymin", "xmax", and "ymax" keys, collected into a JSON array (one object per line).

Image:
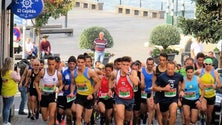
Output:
[{"xmin": 181, "ymin": 66, "xmax": 204, "ymax": 125}]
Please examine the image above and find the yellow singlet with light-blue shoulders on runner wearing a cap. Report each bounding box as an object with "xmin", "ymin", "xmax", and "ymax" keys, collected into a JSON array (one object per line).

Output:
[{"xmin": 200, "ymin": 69, "xmax": 216, "ymax": 98}]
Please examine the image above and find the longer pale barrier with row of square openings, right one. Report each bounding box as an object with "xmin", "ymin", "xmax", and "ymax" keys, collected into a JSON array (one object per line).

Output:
[{"xmin": 115, "ymin": 5, "xmax": 165, "ymax": 19}]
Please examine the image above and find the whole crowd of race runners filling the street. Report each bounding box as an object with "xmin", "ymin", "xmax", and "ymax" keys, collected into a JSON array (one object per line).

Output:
[{"xmin": 11, "ymin": 50, "xmax": 220, "ymax": 125}]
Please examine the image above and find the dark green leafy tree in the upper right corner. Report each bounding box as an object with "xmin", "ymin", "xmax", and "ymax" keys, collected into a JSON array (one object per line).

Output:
[{"xmin": 178, "ymin": 0, "xmax": 222, "ymax": 64}]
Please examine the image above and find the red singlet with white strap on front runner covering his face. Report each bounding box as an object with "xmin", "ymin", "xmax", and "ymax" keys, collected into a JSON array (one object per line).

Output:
[{"xmin": 116, "ymin": 70, "xmax": 134, "ymax": 99}]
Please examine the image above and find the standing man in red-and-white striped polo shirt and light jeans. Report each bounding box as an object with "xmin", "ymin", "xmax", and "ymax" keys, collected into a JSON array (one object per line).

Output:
[{"xmin": 94, "ymin": 32, "xmax": 107, "ymax": 63}]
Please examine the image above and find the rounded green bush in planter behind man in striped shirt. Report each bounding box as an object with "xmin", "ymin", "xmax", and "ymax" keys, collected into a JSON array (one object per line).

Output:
[{"xmin": 79, "ymin": 26, "xmax": 114, "ymax": 64}]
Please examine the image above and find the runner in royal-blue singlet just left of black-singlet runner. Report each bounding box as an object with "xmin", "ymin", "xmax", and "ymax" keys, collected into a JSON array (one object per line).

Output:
[{"xmin": 141, "ymin": 58, "xmax": 154, "ymax": 125}]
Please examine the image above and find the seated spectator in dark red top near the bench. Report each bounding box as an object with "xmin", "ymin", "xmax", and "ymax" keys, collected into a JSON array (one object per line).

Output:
[{"xmin": 40, "ymin": 35, "xmax": 51, "ymax": 59}]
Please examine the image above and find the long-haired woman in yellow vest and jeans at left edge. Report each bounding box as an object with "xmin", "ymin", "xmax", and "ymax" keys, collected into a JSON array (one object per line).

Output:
[{"xmin": 1, "ymin": 57, "xmax": 20, "ymax": 125}]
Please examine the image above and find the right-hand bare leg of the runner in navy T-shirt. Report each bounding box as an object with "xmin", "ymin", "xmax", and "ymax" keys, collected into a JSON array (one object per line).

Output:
[{"xmin": 169, "ymin": 102, "xmax": 177, "ymax": 125}]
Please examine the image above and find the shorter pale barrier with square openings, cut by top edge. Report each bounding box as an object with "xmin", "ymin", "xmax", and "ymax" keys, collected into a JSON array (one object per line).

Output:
[{"xmin": 75, "ymin": 0, "xmax": 103, "ymax": 10}]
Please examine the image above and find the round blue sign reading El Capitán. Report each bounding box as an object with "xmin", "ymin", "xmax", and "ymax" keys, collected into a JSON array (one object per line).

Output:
[{"xmin": 11, "ymin": 0, "xmax": 44, "ymax": 19}]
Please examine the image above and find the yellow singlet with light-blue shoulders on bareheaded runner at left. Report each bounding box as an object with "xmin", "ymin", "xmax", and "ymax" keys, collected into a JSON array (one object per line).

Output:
[{"xmin": 74, "ymin": 67, "xmax": 93, "ymax": 96}]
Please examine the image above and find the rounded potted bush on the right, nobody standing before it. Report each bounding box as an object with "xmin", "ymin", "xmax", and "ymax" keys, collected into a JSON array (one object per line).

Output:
[{"xmin": 149, "ymin": 24, "xmax": 180, "ymax": 63}]
